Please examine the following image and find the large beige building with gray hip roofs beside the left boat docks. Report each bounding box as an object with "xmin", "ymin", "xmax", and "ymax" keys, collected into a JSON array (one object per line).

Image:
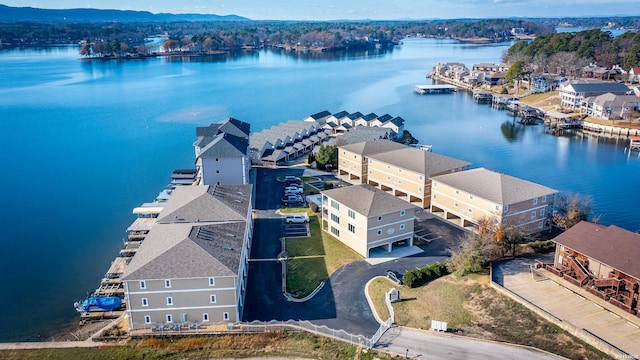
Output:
[{"xmin": 122, "ymin": 185, "xmax": 253, "ymax": 330}]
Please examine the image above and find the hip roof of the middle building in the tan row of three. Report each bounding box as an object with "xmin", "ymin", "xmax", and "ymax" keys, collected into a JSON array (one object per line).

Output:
[{"xmin": 369, "ymin": 148, "xmax": 470, "ymax": 177}]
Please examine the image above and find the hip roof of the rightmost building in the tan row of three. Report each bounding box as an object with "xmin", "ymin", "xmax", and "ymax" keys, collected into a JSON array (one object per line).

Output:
[{"xmin": 432, "ymin": 168, "xmax": 558, "ymax": 205}]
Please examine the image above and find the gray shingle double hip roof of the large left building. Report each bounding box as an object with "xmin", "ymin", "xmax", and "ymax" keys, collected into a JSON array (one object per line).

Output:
[{"xmin": 123, "ymin": 185, "xmax": 251, "ymax": 280}]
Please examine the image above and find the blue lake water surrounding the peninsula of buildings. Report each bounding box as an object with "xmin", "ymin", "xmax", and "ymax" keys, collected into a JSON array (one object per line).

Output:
[{"xmin": 0, "ymin": 39, "xmax": 640, "ymax": 341}]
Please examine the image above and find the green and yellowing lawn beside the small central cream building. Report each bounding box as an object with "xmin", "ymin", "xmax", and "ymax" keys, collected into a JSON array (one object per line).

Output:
[{"xmin": 285, "ymin": 209, "xmax": 362, "ymax": 297}]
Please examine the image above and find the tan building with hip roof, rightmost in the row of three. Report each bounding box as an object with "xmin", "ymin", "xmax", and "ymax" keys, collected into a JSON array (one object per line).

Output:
[{"xmin": 430, "ymin": 168, "xmax": 557, "ymax": 234}]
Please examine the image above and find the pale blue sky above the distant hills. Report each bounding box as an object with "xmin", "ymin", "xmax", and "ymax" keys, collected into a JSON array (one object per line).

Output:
[{"xmin": 0, "ymin": 0, "xmax": 640, "ymax": 20}]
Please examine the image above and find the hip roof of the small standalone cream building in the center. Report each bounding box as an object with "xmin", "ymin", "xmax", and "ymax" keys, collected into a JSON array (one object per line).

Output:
[{"xmin": 322, "ymin": 184, "xmax": 417, "ymax": 217}]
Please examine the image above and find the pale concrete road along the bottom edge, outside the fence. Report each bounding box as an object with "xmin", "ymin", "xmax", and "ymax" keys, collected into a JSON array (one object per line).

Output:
[{"xmin": 376, "ymin": 327, "xmax": 562, "ymax": 360}]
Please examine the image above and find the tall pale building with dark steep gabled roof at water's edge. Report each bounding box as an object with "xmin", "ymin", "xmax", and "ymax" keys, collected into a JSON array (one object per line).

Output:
[{"xmin": 193, "ymin": 118, "xmax": 251, "ymax": 185}]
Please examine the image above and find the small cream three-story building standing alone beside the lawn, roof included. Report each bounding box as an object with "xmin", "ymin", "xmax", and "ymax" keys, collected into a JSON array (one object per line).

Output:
[{"xmin": 322, "ymin": 184, "xmax": 418, "ymax": 258}]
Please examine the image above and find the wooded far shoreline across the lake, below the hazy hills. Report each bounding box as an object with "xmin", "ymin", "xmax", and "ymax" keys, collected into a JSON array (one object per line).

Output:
[{"xmin": 0, "ymin": 19, "xmax": 553, "ymax": 55}]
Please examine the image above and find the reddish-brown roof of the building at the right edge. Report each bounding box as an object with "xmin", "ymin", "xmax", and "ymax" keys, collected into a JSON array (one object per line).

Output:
[{"xmin": 553, "ymin": 221, "xmax": 640, "ymax": 279}]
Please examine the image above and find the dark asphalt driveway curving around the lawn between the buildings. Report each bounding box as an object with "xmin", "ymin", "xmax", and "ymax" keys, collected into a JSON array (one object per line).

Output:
[{"xmin": 243, "ymin": 168, "xmax": 463, "ymax": 337}]
